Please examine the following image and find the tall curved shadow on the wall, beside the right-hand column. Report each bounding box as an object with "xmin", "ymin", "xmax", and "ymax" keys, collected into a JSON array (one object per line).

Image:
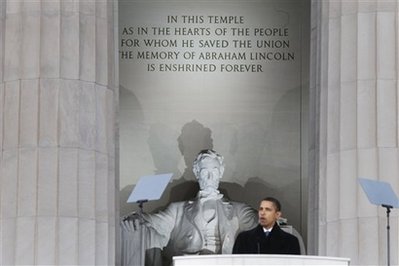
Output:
[{"xmin": 264, "ymin": 86, "xmax": 307, "ymax": 235}]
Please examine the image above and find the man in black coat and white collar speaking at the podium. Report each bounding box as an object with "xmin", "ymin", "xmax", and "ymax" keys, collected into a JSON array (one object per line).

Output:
[{"xmin": 233, "ymin": 197, "xmax": 300, "ymax": 255}]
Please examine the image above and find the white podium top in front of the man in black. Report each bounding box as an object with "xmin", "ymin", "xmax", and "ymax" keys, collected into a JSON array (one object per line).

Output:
[{"xmin": 173, "ymin": 254, "xmax": 350, "ymax": 266}]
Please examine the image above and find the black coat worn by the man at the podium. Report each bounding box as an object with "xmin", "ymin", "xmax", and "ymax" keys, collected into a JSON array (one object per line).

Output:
[{"xmin": 233, "ymin": 224, "xmax": 301, "ymax": 255}]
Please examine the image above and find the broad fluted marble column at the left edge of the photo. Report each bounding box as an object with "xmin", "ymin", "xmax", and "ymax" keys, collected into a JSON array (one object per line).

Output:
[{"xmin": 0, "ymin": 0, "xmax": 117, "ymax": 265}]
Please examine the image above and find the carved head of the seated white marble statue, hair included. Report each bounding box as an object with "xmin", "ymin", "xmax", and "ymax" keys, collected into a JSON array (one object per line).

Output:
[{"xmin": 193, "ymin": 150, "xmax": 224, "ymax": 192}]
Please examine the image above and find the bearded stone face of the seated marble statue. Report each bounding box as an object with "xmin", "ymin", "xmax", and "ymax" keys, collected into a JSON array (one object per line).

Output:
[{"xmin": 197, "ymin": 158, "xmax": 221, "ymax": 191}]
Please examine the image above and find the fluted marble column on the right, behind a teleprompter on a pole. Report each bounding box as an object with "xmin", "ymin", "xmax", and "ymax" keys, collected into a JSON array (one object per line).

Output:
[{"xmin": 311, "ymin": 0, "xmax": 399, "ymax": 265}]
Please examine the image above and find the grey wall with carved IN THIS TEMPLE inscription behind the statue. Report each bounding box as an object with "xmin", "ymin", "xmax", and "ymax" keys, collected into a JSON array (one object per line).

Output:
[{"xmin": 119, "ymin": 0, "xmax": 309, "ymax": 242}]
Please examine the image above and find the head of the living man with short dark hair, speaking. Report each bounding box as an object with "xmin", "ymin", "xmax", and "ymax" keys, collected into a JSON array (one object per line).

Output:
[{"xmin": 258, "ymin": 197, "xmax": 281, "ymax": 229}]
